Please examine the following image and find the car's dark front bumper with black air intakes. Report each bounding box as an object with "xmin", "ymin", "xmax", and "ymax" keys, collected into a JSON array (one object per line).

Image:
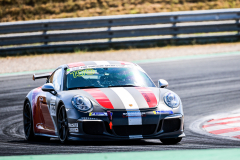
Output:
[{"xmin": 65, "ymin": 111, "xmax": 185, "ymax": 141}]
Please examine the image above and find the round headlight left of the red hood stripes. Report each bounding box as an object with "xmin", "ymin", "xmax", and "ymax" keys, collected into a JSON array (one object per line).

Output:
[{"xmin": 72, "ymin": 95, "xmax": 92, "ymax": 111}]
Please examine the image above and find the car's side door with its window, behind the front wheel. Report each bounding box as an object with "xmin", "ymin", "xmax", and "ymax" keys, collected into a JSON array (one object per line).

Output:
[{"xmin": 40, "ymin": 68, "xmax": 62, "ymax": 135}]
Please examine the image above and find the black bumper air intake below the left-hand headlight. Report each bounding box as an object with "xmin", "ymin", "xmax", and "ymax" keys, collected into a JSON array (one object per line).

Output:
[{"xmin": 82, "ymin": 121, "xmax": 104, "ymax": 135}]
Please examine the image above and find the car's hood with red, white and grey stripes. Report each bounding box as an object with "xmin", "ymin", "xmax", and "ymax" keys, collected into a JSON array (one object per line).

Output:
[{"xmin": 69, "ymin": 87, "xmax": 160, "ymax": 109}]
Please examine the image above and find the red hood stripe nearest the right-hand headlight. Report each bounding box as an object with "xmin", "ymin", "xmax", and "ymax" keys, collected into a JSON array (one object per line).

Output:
[{"xmin": 135, "ymin": 87, "xmax": 157, "ymax": 108}]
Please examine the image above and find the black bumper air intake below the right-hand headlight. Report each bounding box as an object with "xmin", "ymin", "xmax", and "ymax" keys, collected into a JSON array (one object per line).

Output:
[{"xmin": 163, "ymin": 118, "xmax": 181, "ymax": 132}]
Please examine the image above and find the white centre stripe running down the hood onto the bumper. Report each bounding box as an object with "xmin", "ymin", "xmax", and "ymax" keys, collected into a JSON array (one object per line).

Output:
[{"xmin": 111, "ymin": 87, "xmax": 142, "ymax": 125}]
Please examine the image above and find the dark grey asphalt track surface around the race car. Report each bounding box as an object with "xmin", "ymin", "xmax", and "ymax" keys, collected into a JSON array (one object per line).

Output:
[{"xmin": 0, "ymin": 56, "xmax": 240, "ymax": 156}]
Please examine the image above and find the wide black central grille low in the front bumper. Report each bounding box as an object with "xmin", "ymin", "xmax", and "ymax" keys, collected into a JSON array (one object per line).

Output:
[{"xmin": 113, "ymin": 124, "xmax": 156, "ymax": 136}]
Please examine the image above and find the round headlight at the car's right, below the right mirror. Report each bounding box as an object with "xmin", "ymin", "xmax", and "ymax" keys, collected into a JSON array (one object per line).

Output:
[{"xmin": 164, "ymin": 92, "xmax": 180, "ymax": 108}]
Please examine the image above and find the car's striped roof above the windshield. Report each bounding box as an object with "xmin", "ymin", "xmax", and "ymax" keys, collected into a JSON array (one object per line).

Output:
[{"xmin": 67, "ymin": 61, "xmax": 135, "ymax": 68}]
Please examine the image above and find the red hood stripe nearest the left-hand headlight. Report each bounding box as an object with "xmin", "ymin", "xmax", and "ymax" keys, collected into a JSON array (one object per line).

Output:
[{"xmin": 83, "ymin": 89, "xmax": 114, "ymax": 109}]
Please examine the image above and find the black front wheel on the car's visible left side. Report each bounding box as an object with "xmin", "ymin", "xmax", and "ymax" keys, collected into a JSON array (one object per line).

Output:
[{"xmin": 58, "ymin": 105, "xmax": 68, "ymax": 143}]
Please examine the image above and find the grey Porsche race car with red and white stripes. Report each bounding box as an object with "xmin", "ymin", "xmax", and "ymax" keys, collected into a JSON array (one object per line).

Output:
[{"xmin": 23, "ymin": 61, "xmax": 185, "ymax": 144}]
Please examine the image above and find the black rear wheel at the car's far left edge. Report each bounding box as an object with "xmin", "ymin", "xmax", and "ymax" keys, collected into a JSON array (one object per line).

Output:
[{"xmin": 23, "ymin": 102, "xmax": 34, "ymax": 141}]
